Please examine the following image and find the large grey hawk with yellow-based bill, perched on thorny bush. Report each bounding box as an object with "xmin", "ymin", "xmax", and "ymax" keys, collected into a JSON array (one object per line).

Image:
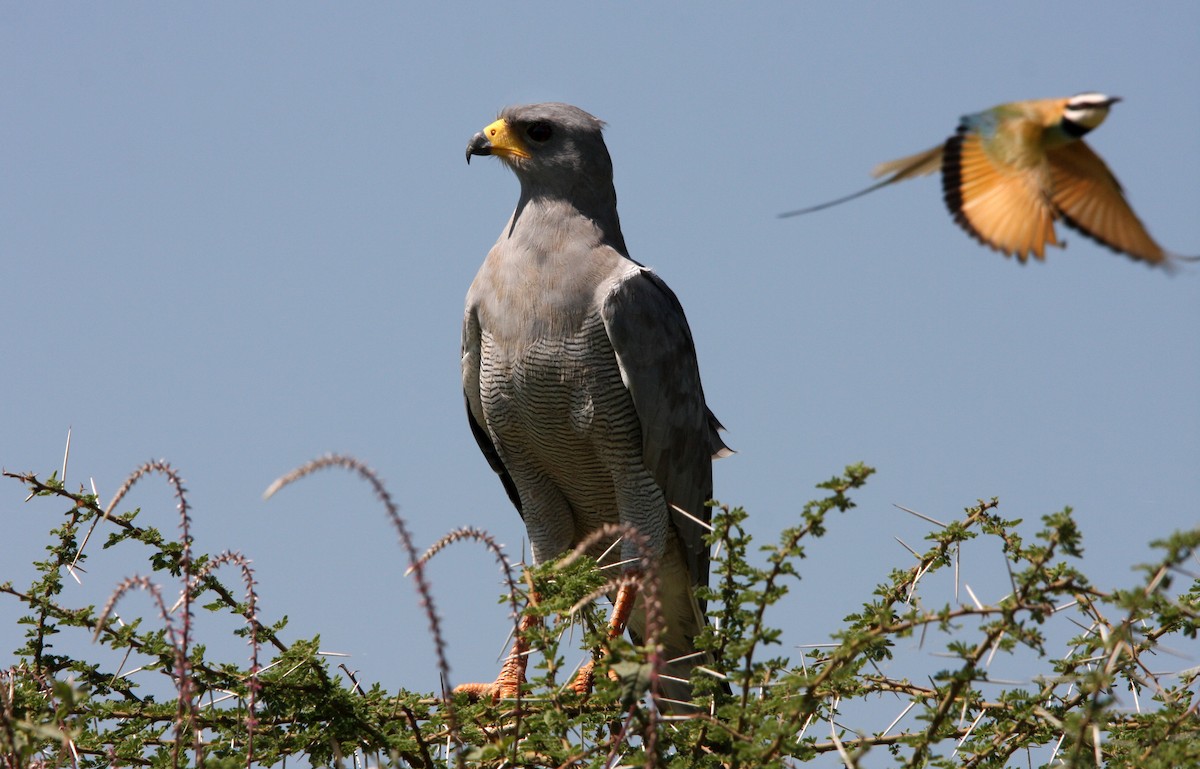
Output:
[{"xmin": 462, "ymin": 103, "xmax": 730, "ymax": 699}]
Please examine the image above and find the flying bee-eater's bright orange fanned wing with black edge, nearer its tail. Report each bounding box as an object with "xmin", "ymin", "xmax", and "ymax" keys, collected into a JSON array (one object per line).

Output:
[{"xmin": 942, "ymin": 124, "xmax": 1058, "ymax": 262}]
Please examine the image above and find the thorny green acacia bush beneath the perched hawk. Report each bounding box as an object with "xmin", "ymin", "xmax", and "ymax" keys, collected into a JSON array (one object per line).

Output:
[{"xmin": 0, "ymin": 456, "xmax": 1200, "ymax": 769}]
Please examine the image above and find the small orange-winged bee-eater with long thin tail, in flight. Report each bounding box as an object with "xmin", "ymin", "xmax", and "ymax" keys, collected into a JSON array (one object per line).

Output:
[{"xmin": 780, "ymin": 92, "xmax": 1200, "ymax": 265}]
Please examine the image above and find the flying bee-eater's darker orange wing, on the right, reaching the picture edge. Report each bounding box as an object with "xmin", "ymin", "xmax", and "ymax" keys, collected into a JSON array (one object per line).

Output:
[{"xmin": 1046, "ymin": 142, "xmax": 1195, "ymax": 264}]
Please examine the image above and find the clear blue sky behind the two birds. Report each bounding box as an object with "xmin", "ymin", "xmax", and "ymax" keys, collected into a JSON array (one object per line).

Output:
[{"xmin": 0, "ymin": 2, "xmax": 1200, "ymax": 728}]
